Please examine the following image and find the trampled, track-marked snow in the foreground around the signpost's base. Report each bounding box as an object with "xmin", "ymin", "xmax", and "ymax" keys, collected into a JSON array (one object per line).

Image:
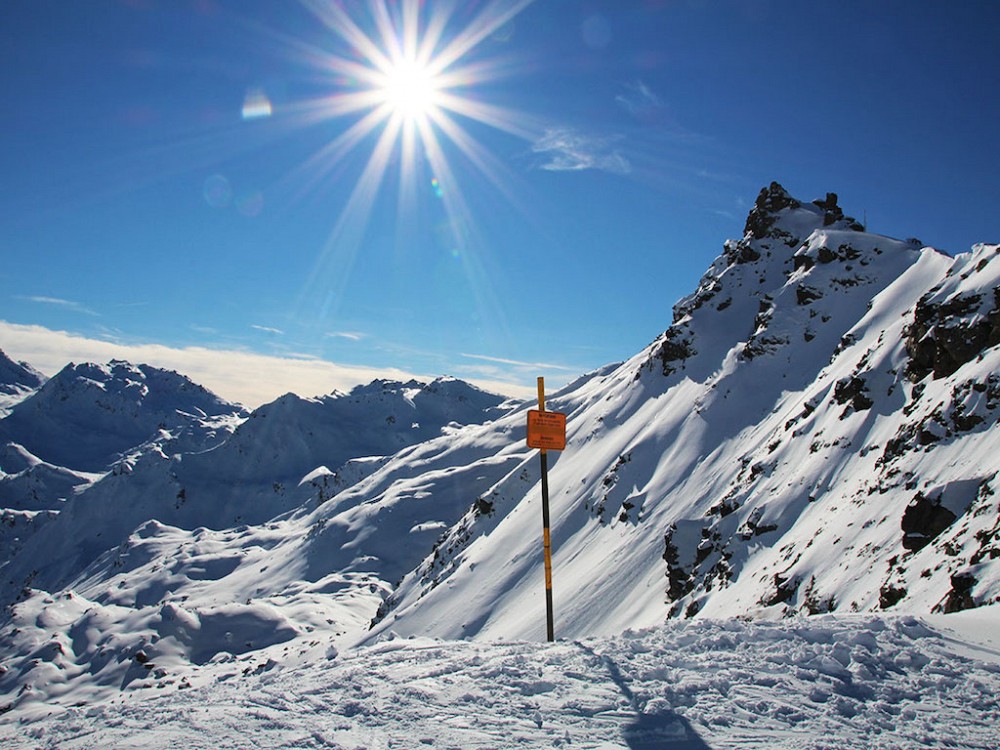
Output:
[{"xmin": 0, "ymin": 607, "xmax": 1000, "ymax": 750}]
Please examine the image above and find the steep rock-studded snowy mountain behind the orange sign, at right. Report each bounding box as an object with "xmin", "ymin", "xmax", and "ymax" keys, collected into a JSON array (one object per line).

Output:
[{"xmin": 368, "ymin": 185, "xmax": 1000, "ymax": 638}]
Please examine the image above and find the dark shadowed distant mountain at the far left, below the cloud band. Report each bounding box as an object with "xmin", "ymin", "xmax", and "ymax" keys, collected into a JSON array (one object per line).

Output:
[{"xmin": 0, "ymin": 362, "xmax": 246, "ymax": 520}]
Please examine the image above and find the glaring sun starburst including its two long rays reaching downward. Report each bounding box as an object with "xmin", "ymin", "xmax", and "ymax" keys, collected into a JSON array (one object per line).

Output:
[{"xmin": 286, "ymin": 0, "xmax": 542, "ymax": 340}]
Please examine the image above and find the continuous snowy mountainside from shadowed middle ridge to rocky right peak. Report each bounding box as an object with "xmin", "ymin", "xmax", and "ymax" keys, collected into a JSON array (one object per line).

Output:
[{"xmin": 0, "ymin": 183, "xmax": 1000, "ymax": 728}]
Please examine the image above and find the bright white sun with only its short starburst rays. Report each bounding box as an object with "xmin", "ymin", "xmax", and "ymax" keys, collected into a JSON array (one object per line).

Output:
[{"xmin": 292, "ymin": 0, "xmax": 534, "ymax": 198}]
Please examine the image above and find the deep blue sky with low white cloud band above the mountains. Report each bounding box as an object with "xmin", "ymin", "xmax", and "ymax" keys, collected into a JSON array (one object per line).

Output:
[{"xmin": 0, "ymin": 0, "xmax": 1000, "ymax": 403}]
